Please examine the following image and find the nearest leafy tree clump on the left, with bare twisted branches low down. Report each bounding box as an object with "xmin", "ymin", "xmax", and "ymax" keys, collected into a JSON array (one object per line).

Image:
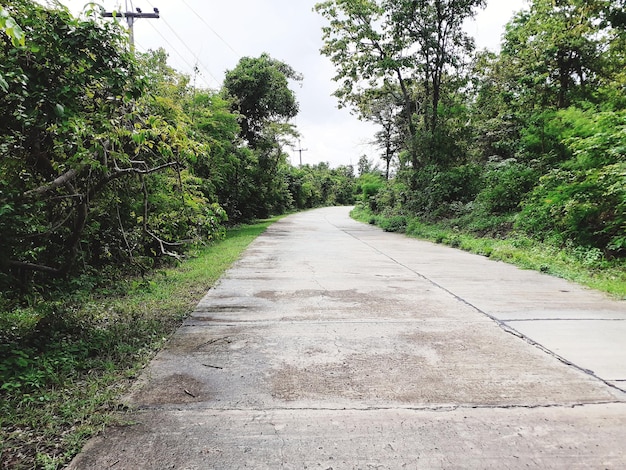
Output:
[{"xmin": 0, "ymin": 0, "xmax": 221, "ymax": 282}]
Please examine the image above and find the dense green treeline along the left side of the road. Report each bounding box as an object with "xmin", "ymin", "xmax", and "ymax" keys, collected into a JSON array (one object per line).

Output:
[{"xmin": 0, "ymin": 0, "xmax": 354, "ymax": 304}]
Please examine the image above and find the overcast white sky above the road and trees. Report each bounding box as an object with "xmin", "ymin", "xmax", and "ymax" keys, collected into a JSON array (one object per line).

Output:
[{"xmin": 56, "ymin": 0, "xmax": 526, "ymax": 167}]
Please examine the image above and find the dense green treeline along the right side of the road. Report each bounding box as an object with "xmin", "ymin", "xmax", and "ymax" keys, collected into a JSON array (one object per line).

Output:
[{"xmin": 316, "ymin": 0, "xmax": 626, "ymax": 259}]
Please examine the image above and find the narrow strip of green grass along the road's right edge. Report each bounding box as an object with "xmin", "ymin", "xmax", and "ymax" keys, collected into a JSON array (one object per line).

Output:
[{"xmin": 351, "ymin": 207, "xmax": 626, "ymax": 299}]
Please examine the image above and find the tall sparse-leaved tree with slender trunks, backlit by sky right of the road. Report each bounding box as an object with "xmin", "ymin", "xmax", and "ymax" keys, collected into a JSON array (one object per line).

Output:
[{"xmin": 315, "ymin": 0, "xmax": 485, "ymax": 171}]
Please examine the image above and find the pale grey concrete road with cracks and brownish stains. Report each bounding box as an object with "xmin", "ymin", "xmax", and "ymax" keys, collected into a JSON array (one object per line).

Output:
[{"xmin": 71, "ymin": 208, "xmax": 626, "ymax": 470}]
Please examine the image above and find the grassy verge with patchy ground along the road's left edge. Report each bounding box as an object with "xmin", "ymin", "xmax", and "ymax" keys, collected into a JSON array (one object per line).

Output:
[{"xmin": 0, "ymin": 219, "xmax": 276, "ymax": 470}]
